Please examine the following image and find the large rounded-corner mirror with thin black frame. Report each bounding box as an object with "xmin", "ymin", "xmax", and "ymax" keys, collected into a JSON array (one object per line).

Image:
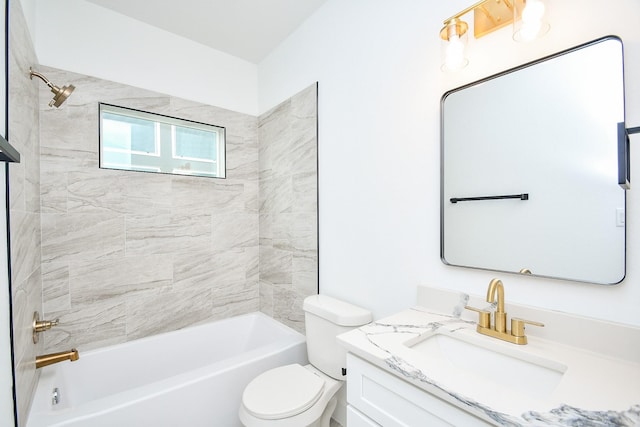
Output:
[{"xmin": 441, "ymin": 37, "xmax": 625, "ymax": 284}]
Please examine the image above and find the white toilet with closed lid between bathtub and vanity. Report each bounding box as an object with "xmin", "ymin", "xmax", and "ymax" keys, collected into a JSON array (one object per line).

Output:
[{"xmin": 239, "ymin": 295, "xmax": 371, "ymax": 427}]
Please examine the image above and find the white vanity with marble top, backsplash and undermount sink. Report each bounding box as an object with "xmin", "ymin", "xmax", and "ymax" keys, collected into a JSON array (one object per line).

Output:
[{"xmin": 338, "ymin": 284, "xmax": 640, "ymax": 427}]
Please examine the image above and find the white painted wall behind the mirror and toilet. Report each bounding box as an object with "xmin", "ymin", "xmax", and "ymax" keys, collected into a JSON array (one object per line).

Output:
[{"xmin": 258, "ymin": 0, "xmax": 640, "ymax": 325}]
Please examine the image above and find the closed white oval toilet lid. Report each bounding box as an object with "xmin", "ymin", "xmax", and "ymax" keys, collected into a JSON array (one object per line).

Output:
[{"xmin": 242, "ymin": 364, "xmax": 324, "ymax": 420}]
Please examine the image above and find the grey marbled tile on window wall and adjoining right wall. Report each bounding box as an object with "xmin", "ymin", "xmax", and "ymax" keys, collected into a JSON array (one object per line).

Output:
[{"xmin": 40, "ymin": 67, "xmax": 317, "ymax": 351}]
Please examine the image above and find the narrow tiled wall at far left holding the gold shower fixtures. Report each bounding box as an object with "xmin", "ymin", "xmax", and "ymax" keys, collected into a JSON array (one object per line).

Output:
[{"xmin": 7, "ymin": 1, "xmax": 43, "ymax": 425}]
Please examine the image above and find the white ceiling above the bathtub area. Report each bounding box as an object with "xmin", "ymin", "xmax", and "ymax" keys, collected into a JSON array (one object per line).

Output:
[{"xmin": 87, "ymin": 0, "xmax": 327, "ymax": 64}]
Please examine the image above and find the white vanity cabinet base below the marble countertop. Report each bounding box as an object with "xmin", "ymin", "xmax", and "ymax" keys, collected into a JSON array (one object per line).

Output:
[{"xmin": 347, "ymin": 353, "xmax": 492, "ymax": 427}]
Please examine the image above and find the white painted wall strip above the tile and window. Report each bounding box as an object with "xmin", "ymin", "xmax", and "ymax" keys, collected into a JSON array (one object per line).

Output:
[{"xmin": 31, "ymin": 0, "xmax": 258, "ymax": 115}]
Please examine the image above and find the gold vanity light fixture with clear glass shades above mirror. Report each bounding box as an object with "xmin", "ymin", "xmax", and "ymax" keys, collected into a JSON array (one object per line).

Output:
[{"xmin": 440, "ymin": 0, "xmax": 550, "ymax": 71}]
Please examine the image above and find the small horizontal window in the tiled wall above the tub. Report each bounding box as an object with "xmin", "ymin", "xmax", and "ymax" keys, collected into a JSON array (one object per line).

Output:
[{"xmin": 100, "ymin": 104, "xmax": 225, "ymax": 178}]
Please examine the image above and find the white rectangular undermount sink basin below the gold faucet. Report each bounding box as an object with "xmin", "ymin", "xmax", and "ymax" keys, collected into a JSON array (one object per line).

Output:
[{"xmin": 406, "ymin": 333, "xmax": 567, "ymax": 397}]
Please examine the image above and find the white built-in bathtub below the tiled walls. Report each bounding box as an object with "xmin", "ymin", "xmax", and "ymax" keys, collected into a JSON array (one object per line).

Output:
[{"xmin": 26, "ymin": 313, "xmax": 307, "ymax": 427}]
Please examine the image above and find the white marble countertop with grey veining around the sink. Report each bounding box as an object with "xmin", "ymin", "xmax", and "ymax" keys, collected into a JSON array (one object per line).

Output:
[{"xmin": 338, "ymin": 290, "xmax": 640, "ymax": 426}]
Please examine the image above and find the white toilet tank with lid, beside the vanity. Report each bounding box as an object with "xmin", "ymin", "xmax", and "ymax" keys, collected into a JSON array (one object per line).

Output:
[{"xmin": 302, "ymin": 295, "xmax": 371, "ymax": 380}]
